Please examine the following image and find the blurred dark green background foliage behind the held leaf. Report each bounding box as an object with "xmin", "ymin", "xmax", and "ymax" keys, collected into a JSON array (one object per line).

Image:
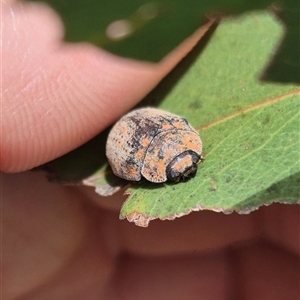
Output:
[{"xmin": 27, "ymin": 0, "xmax": 300, "ymax": 82}]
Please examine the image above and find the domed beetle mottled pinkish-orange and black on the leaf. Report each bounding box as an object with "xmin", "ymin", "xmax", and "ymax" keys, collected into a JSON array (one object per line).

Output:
[{"xmin": 106, "ymin": 107, "xmax": 203, "ymax": 183}]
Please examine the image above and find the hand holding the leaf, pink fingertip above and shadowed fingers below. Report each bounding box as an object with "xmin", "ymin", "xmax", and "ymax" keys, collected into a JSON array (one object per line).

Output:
[{"xmin": 0, "ymin": 1, "xmax": 300, "ymax": 300}]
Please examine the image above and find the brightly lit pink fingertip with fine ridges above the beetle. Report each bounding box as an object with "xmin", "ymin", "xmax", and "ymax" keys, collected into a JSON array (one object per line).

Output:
[{"xmin": 1, "ymin": 3, "xmax": 212, "ymax": 172}]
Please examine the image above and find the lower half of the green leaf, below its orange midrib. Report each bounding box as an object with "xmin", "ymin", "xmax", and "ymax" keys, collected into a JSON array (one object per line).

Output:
[{"xmin": 121, "ymin": 93, "xmax": 300, "ymax": 226}]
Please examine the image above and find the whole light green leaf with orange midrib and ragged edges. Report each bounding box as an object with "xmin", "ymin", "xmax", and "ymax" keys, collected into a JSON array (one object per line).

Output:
[{"xmin": 120, "ymin": 14, "xmax": 300, "ymax": 226}]
